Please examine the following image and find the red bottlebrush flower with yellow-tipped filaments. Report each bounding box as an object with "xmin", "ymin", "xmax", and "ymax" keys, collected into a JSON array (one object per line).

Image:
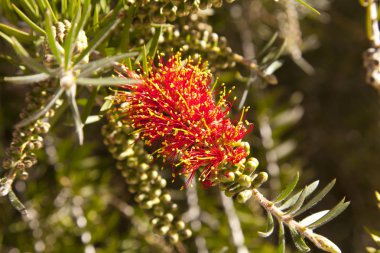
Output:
[{"xmin": 117, "ymin": 53, "xmax": 251, "ymax": 185}]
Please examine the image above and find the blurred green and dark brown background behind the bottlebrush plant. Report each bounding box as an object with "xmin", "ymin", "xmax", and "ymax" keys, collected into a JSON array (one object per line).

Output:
[{"xmin": 0, "ymin": 0, "xmax": 380, "ymax": 253}]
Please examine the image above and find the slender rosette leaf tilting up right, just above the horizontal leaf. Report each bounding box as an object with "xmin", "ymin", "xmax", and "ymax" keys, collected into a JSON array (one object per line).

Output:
[{"xmin": 77, "ymin": 52, "xmax": 138, "ymax": 77}]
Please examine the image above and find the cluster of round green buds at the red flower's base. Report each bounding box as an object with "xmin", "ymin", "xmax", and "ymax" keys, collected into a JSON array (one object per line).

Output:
[{"xmin": 213, "ymin": 141, "xmax": 268, "ymax": 203}]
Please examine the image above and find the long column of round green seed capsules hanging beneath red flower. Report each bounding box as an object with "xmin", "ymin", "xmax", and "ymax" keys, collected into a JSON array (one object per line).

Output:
[{"xmin": 102, "ymin": 113, "xmax": 191, "ymax": 244}]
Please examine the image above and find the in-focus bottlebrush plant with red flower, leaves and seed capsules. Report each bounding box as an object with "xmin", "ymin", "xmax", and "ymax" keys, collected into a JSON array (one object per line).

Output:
[{"xmin": 0, "ymin": 0, "xmax": 348, "ymax": 252}]
